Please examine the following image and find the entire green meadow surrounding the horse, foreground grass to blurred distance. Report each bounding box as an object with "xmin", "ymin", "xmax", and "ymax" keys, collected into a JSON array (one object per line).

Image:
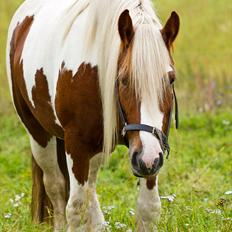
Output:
[{"xmin": 0, "ymin": 0, "xmax": 232, "ymax": 232}]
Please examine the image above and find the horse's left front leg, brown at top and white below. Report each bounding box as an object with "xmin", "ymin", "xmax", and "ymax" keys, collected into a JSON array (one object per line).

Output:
[{"xmin": 65, "ymin": 132, "xmax": 104, "ymax": 232}]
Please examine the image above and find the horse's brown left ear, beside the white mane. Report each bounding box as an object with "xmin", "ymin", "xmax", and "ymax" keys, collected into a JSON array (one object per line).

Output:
[{"xmin": 118, "ymin": 10, "xmax": 134, "ymax": 47}]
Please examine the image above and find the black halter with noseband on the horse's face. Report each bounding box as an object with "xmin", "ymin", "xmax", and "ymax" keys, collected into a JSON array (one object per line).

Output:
[{"xmin": 115, "ymin": 79, "xmax": 179, "ymax": 159}]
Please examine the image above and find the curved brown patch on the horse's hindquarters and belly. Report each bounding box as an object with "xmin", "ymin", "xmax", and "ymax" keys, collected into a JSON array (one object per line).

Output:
[{"xmin": 10, "ymin": 16, "xmax": 63, "ymax": 147}]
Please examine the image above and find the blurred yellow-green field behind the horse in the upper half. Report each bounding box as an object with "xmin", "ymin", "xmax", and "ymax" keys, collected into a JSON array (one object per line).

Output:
[{"xmin": 0, "ymin": 0, "xmax": 232, "ymax": 112}]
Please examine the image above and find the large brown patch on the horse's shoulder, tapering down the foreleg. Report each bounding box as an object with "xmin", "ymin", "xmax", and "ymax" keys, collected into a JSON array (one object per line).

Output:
[{"xmin": 55, "ymin": 63, "xmax": 103, "ymax": 184}]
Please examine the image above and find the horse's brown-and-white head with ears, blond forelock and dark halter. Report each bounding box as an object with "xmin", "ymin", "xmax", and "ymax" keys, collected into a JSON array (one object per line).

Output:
[{"xmin": 118, "ymin": 10, "xmax": 179, "ymax": 177}]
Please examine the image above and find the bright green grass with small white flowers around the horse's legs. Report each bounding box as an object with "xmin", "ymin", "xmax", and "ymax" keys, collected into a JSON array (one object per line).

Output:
[{"xmin": 0, "ymin": 111, "xmax": 232, "ymax": 232}]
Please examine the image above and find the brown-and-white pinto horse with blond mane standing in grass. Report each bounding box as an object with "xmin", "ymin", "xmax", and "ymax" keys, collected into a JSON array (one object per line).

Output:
[{"xmin": 6, "ymin": 0, "xmax": 180, "ymax": 231}]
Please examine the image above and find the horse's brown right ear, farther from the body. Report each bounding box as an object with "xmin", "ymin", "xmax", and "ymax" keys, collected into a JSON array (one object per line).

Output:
[{"xmin": 161, "ymin": 11, "xmax": 180, "ymax": 50}]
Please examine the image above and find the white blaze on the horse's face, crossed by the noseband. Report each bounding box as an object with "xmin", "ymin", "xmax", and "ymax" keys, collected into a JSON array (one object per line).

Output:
[{"xmin": 139, "ymin": 99, "xmax": 163, "ymax": 168}]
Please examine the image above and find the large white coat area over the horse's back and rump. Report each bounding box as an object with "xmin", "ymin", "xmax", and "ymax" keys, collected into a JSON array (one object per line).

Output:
[{"xmin": 7, "ymin": 0, "xmax": 89, "ymax": 100}]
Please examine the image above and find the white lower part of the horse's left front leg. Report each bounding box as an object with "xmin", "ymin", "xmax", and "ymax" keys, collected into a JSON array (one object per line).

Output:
[{"xmin": 66, "ymin": 154, "xmax": 104, "ymax": 232}]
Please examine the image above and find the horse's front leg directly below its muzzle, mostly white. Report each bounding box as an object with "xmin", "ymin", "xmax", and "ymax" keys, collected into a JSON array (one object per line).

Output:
[{"xmin": 137, "ymin": 177, "xmax": 161, "ymax": 232}]
